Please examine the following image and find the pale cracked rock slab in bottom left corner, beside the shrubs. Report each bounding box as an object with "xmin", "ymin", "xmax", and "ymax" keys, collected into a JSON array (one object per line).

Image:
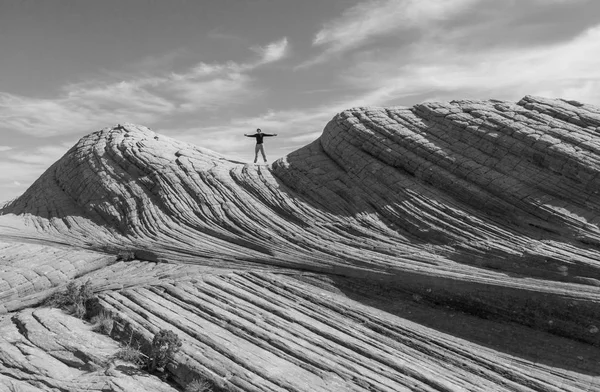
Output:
[{"xmin": 0, "ymin": 309, "xmax": 177, "ymax": 392}]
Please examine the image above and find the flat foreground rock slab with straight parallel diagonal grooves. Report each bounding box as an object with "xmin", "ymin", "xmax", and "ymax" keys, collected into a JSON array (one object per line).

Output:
[{"xmin": 96, "ymin": 273, "xmax": 600, "ymax": 392}]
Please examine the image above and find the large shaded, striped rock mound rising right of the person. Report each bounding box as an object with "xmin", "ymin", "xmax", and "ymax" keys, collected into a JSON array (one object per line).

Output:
[{"xmin": 275, "ymin": 97, "xmax": 600, "ymax": 248}]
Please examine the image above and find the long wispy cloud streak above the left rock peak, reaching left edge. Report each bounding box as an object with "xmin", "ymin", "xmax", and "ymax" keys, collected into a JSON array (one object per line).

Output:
[{"xmin": 0, "ymin": 38, "xmax": 288, "ymax": 137}]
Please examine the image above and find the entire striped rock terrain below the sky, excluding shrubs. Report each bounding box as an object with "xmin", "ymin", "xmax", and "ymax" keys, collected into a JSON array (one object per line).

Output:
[{"xmin": 0, "ymin": 96, "xmax": 600, "ymax": 392}]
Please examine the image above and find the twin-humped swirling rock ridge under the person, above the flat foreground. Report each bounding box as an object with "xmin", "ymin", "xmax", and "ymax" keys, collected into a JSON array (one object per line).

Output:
[{"xmin": 2, "ymin": 96, "xmax": 600, "ymax": 334}]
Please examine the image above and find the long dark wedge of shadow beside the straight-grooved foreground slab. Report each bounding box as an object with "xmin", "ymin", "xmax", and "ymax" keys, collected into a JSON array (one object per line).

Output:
[{"xmin": 331, "ymin": 276, "xmax": 600, "ymax": 376}]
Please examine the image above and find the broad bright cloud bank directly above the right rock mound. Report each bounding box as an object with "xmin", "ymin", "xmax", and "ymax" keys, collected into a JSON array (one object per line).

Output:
[{"xmin": 343, "ymin": 26, "xmax": 600, "ymax": 106}]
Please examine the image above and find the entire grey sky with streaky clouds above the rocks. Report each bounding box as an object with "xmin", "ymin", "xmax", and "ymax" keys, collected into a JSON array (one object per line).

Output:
[{"xmin": 0, "ymin": 0, "xmax": 600, "ymax": 201}]
